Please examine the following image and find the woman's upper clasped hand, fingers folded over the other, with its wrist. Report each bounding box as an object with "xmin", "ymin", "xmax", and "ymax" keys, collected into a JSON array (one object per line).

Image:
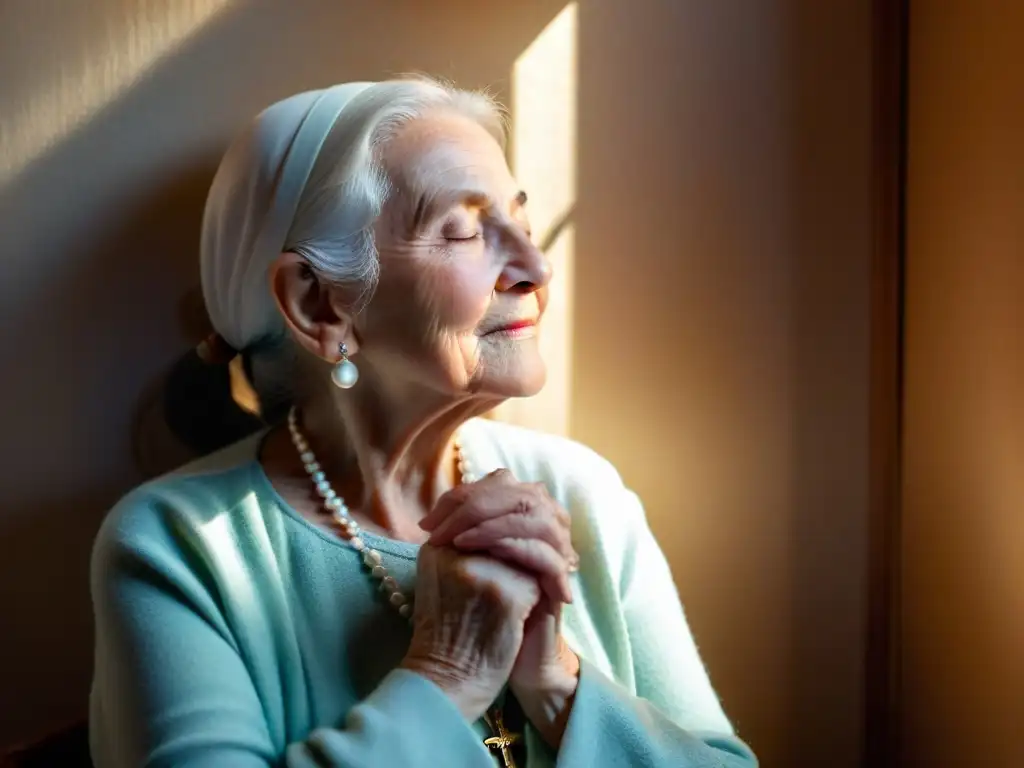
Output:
[{"xmin": 420, "ymin": 470, "xmax": 580, "ymax": 749}]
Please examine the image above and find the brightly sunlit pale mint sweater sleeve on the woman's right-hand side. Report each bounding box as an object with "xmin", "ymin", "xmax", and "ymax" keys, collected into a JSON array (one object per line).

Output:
[{"xmin": 558, "ymin": 492, "xmax": 758, "ymax": 768}]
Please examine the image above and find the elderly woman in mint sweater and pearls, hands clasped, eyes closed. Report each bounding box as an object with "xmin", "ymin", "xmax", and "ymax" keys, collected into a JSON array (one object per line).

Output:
[{"xmin": 91, "ymin": 75, "xmax": 756, "ymax": 768}]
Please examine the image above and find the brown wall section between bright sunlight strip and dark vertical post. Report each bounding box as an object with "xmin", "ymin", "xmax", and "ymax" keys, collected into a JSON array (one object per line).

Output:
[{"xmin": 571, "ymin": 0, "xmax": 871, "ymax": 768}]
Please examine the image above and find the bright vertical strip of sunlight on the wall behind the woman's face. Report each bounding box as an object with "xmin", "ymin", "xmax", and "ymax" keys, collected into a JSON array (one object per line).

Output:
[{"xmin": 497, "ymin": 2, "xmax": 577, "ymax": 434}]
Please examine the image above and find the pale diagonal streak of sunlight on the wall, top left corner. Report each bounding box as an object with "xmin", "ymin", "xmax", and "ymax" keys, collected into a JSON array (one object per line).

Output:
[{"xmin": 0, "ymin": 0, "xmax": 232, "ymax": 185}]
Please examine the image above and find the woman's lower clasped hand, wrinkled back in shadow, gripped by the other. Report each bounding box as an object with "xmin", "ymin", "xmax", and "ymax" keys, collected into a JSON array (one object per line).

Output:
[{"xmin": 400, "ymin": 544, "xmax": 541, "ymax": 722}]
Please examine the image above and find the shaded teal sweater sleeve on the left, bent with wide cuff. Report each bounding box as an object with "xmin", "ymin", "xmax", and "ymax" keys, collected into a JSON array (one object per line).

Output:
[{"xmin": 90, "ymin": 507, "xmax": 494, "ymax": 768}]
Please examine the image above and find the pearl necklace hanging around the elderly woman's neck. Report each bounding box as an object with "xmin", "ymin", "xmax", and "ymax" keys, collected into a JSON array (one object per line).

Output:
[{"xmin": 288, "ymin": 407, "xmax": 476, "ymax": 618}]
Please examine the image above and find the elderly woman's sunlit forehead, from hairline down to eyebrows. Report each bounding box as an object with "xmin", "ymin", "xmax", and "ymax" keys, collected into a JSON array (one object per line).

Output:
[{"xmin": 381, "ymin": 114, "xmax": 518, "ymax": 224}]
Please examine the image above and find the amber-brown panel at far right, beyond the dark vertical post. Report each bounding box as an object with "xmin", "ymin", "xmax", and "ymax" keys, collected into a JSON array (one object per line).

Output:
[{"xmin": 902, "ymin": 0, "xmax": 1024, "ymax": 768}]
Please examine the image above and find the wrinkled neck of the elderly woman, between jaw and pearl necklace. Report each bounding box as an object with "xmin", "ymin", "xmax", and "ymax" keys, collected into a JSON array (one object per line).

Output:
[{"xmin": 299, "ymin": 368, "xmax": 504, "ymax": 541}]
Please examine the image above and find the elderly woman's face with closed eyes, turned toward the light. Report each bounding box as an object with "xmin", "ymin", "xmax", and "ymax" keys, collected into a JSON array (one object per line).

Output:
[{"xmin": 354, "ymin": 113, "xmax": 551, "ymax": 397}]
